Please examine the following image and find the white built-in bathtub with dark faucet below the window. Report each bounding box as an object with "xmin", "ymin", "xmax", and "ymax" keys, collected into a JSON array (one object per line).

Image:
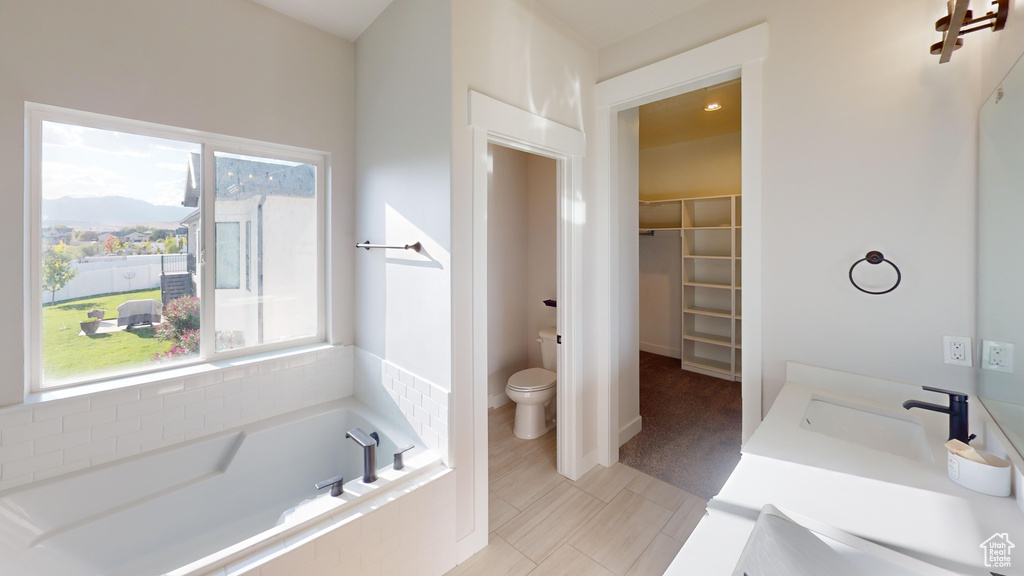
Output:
[{"xmin": 0, "ymin": 398, "xmax": 438, "ymax": 576}]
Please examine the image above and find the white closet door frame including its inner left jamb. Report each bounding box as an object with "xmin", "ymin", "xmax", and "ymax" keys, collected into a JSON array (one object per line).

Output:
[{"xmin": 597, "ymin": 24, "xmax": 768, "ymax": 466}]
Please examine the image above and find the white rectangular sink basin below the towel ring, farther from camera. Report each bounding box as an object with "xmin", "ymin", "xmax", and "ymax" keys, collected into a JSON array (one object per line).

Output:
[{"xmin": 800, "ymin": 396, "xmax": 932, "ymax": 462}]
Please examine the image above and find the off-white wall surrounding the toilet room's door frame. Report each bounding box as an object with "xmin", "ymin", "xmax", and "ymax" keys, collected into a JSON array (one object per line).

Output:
[{"xmin": 449, "ymin": 0, "xmax": 604, "ymax": 549}]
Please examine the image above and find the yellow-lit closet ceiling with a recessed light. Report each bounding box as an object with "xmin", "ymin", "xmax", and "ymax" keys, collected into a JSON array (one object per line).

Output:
[{"xmin": 640, "ymin": 80, "xmax": 740, "ymax": 150}]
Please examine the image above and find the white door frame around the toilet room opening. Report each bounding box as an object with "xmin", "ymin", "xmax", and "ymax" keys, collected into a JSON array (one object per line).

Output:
[{"xmin": 468, "ymin": 90, "xmax": 587, "ymax": 547}]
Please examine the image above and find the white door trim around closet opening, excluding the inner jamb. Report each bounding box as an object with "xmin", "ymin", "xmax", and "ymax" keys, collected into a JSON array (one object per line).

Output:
[{"xmin": 596, "ymin": 24, "xmax": 768, "ymax": 466}]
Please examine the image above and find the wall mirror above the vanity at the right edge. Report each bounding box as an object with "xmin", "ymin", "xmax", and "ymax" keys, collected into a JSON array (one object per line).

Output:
[{"xmin": 977, "ymin": 51, "xmax": 1024, "ymax": 454}]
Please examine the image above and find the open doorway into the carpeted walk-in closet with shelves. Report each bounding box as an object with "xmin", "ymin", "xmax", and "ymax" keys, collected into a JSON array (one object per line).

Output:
[{"xmin": 618, "ymin": 79, "xmax": 742, "ymax": 499}]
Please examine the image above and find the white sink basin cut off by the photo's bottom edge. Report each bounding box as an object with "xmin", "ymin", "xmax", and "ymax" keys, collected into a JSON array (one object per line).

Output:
[{"xmin": 732, "ymin": 504, "xmax": 954, "ymax": 576}]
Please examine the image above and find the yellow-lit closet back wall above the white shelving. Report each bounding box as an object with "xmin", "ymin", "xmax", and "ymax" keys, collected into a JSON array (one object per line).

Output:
[{"xmin": 640, "ymin": 132, "xmax": 740, "ymax": 200}]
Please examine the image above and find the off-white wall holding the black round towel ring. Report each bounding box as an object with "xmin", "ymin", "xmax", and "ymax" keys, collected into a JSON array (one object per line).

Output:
[{"xmin": 599, "ymin": 0, "xmax": 983, "ymax": 408}]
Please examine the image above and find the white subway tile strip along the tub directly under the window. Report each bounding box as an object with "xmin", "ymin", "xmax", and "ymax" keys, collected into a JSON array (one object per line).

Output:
[{"xmin": 0, "ymin": 345, "xmax": 354, "ymax": 491}]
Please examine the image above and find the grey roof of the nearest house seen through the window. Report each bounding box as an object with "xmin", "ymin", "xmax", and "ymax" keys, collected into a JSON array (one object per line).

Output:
[{"xmin": 181, "ymin": 154, "xmax": 316, "ymax": 204}]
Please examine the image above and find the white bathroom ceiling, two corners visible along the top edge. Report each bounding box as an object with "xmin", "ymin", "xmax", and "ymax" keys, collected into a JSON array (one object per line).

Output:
[{"xmin": 246, "ymin": 0, "xmax": 711, "ymax": 48}]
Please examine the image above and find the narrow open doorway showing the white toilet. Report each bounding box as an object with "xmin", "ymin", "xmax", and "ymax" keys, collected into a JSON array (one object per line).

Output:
[{"xmin": 487, "ymin": 143, "xmax": 560, "ymax": 487}]
